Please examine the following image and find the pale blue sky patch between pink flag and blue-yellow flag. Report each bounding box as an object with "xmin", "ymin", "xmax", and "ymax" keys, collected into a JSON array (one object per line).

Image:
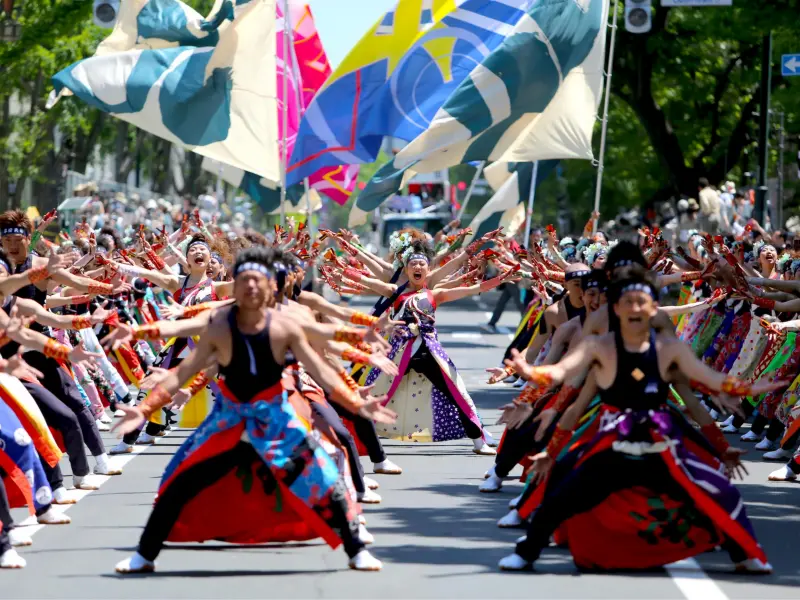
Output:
[{"xmin": 308, "ymin": 0, "xmax": 397, "ymax": 69}]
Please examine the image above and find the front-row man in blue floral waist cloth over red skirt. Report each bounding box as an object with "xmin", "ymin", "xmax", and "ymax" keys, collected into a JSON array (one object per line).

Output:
[{"xmin": 111, "ymin": 248, "xmax": 395, "ymax": 573}]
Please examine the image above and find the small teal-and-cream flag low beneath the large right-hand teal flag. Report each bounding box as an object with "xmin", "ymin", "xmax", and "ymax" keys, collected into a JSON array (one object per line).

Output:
[{"xmin": 467, "ymin": 160, "xmax": 558, "ymax": 241}]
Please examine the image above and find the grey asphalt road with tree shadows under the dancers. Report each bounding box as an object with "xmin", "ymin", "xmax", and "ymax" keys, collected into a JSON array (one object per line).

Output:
[{"xmin": 0, "ymin": 298, "xmax": 800, "ymax": 600}]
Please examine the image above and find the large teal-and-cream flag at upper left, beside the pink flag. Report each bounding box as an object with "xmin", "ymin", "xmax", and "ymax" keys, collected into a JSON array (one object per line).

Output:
[{"xmin": 53, "ymin": 0, "xmax": 280, "ymax": 181}]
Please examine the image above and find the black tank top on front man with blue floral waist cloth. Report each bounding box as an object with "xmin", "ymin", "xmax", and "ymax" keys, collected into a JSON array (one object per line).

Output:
[{"xmin": 219, "ymin": 306, "xmax": 283, "ymax": 402}]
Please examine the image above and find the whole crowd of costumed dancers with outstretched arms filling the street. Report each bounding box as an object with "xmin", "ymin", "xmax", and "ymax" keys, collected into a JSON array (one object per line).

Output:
[{"xmin": 0, "ymin": 211, "xmax": 788, "ymax": 573}]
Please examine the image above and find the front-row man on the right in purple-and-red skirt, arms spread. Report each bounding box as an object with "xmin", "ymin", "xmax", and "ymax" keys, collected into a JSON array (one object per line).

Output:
[{"xmin": 500, "ymin": 267, "xmax": 781, "ymax": 572}]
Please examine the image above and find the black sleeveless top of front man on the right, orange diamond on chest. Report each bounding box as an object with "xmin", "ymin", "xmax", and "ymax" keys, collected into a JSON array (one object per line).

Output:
[{"xmin": 600, "ymin": 329, "xmax": 669, "ymax": 411}]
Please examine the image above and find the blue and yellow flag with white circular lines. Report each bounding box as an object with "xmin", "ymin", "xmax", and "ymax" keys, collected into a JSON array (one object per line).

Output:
[{"xmin": 288, "ymin": 0, "xmax": 530, "ymax": 185}]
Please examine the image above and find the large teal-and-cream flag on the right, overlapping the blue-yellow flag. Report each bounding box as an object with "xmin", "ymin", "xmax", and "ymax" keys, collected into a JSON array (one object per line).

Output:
[{"xmin": 354, "ymin": 0, "xmax": 608, "ymax": 220}]
